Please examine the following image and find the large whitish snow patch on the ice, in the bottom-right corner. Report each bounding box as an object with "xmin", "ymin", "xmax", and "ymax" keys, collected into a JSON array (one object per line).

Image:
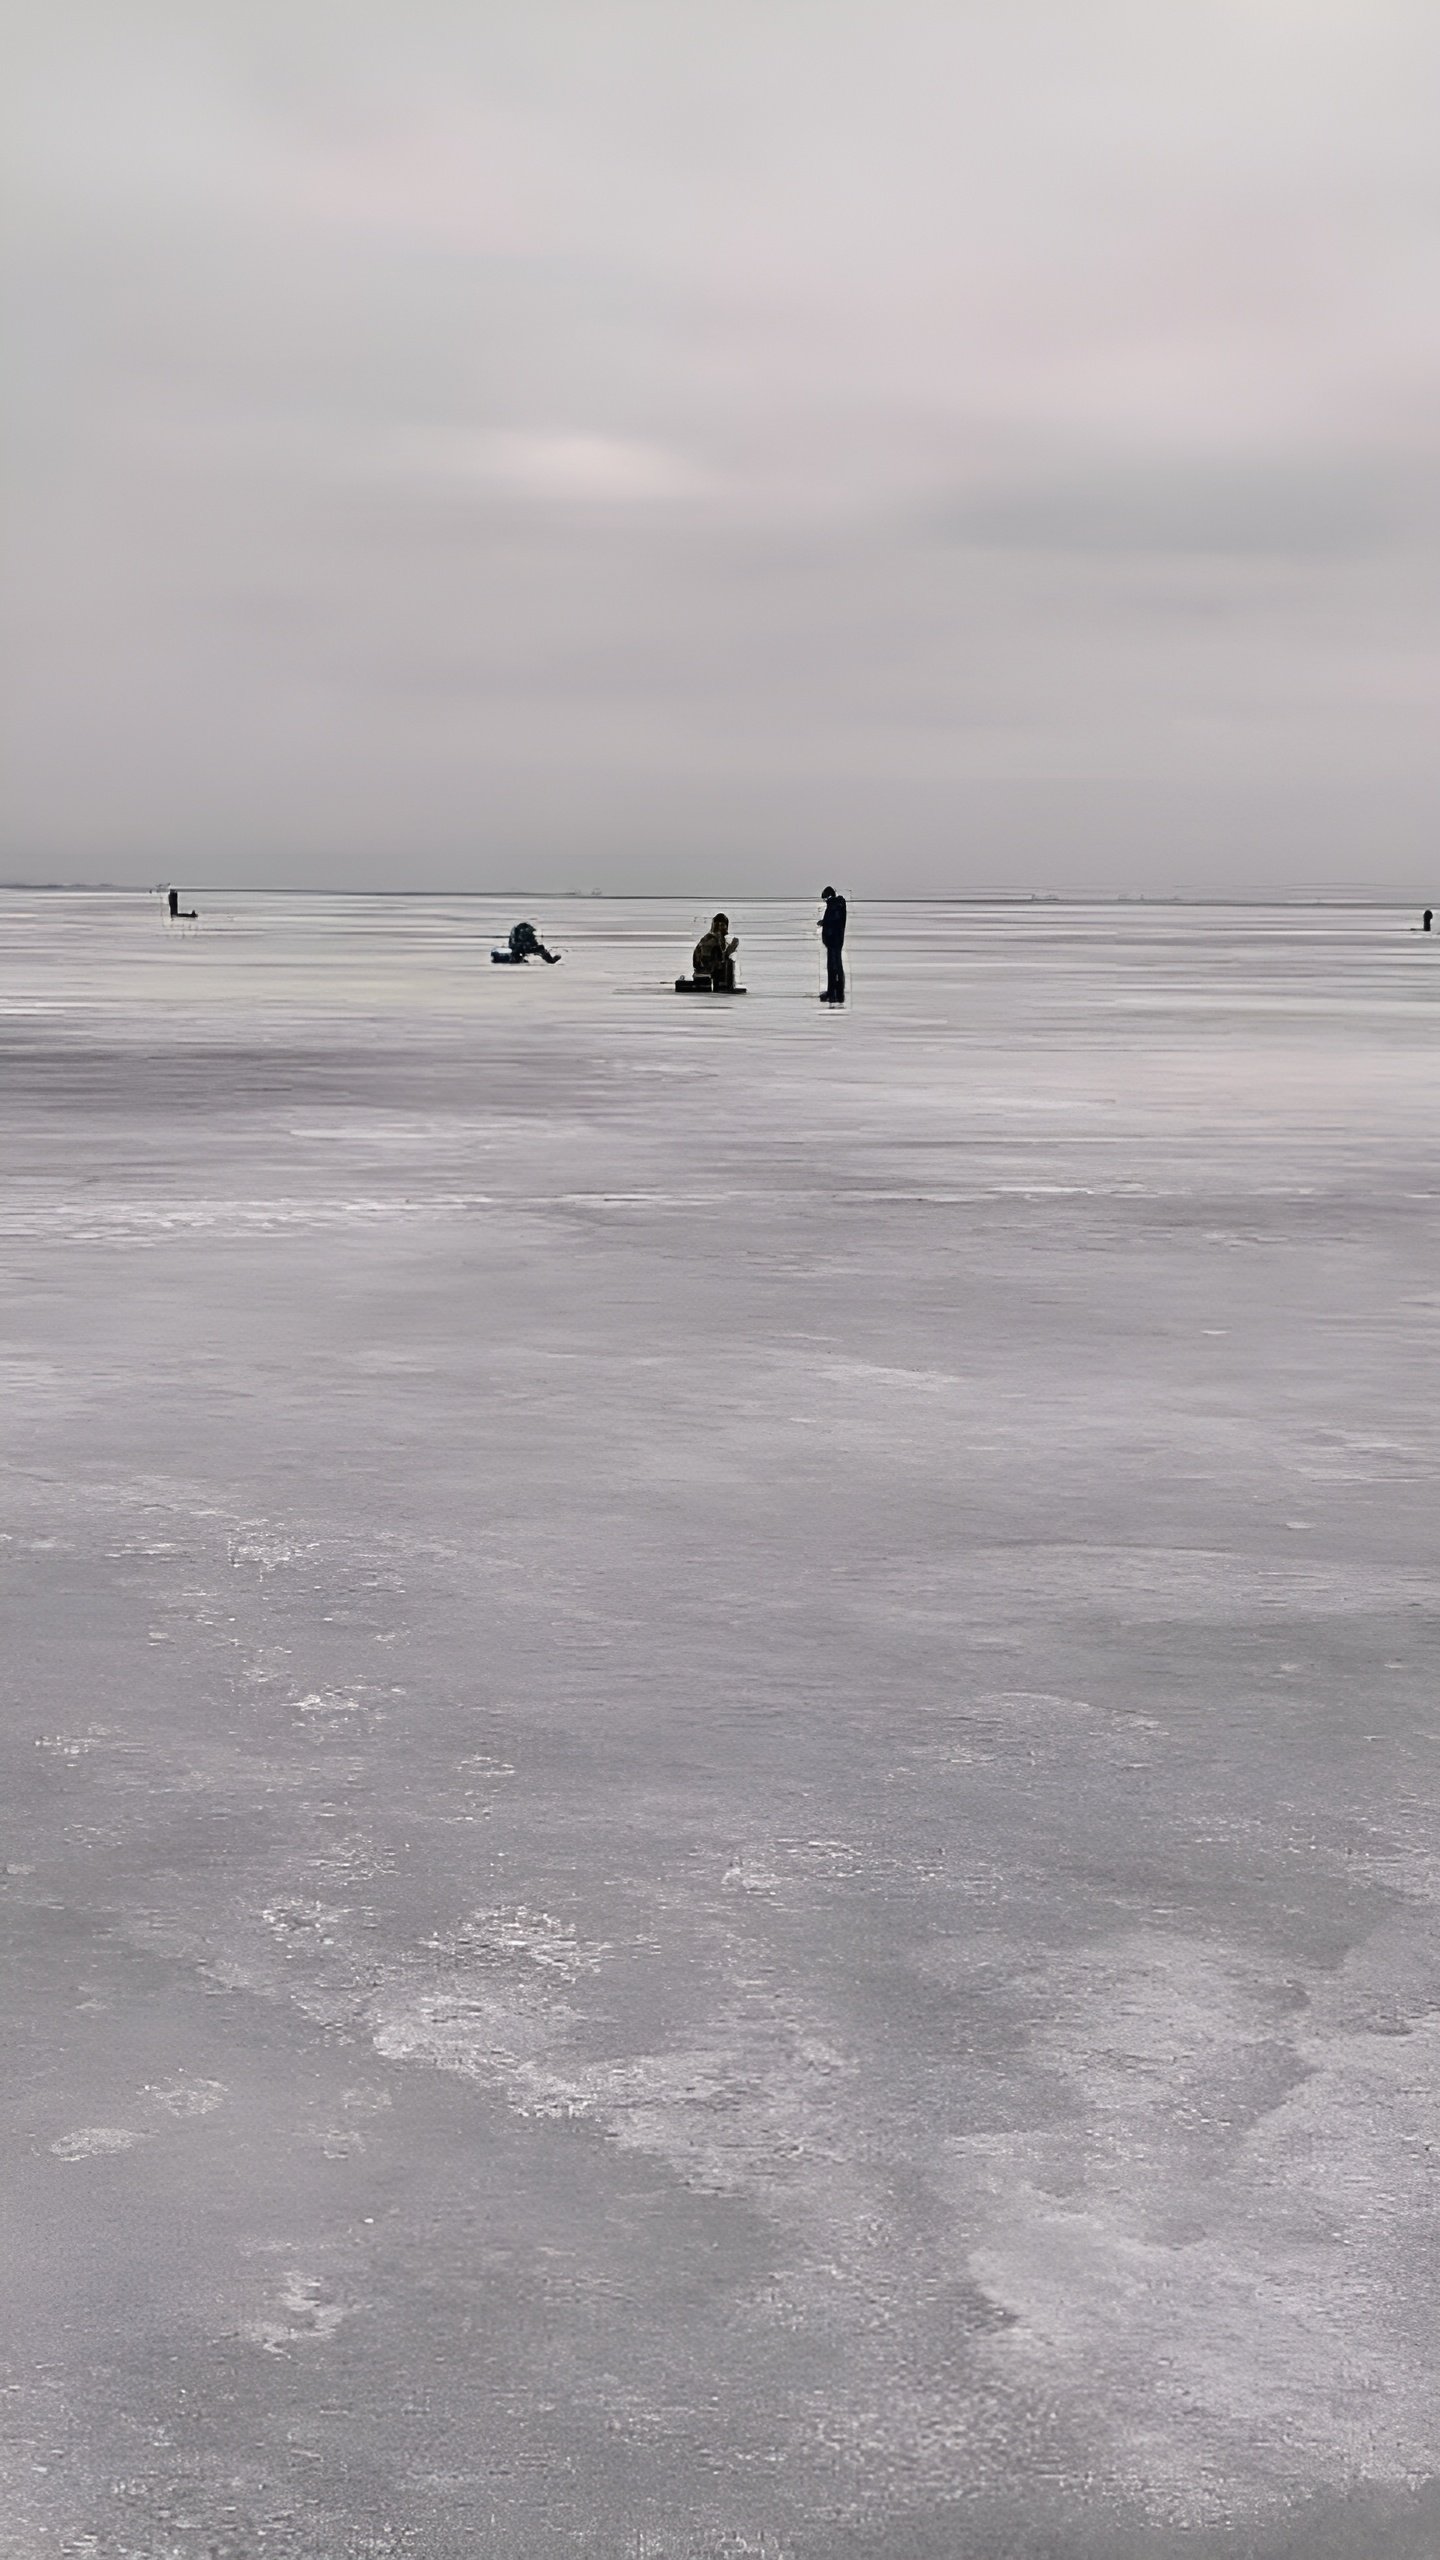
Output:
[{"xmin": 951, "ymin": 1933, "xmax": 1440, "ymax": 2524}]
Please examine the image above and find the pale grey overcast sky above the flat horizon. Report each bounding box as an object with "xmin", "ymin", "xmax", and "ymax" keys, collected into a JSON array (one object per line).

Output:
[{"xmin": 0, "ymin": 0, "xmax": 1440, "ymax": 899}]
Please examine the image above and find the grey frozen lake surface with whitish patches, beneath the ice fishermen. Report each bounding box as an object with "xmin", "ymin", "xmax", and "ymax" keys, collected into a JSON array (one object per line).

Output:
[{"xmin": 0, "ymin": 893, "xmax": 1440, "ymax": 2560}]
